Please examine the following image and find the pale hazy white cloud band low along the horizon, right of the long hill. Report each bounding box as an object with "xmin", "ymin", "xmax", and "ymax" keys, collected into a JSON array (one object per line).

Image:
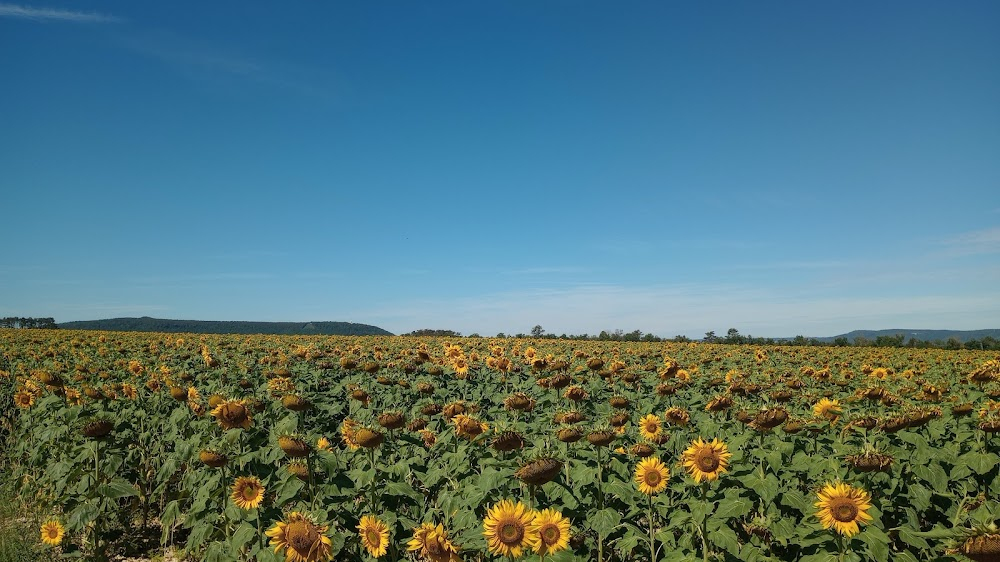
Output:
[{"xmin": 350, "ymin": 285, "xmax": 1000, "ymax": 337}]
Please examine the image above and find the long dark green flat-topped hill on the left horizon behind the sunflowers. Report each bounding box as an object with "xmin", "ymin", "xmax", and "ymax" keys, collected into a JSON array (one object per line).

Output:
[{"xmin": 59, "ymin": 316, "xmax": 392, "ymax": 336}]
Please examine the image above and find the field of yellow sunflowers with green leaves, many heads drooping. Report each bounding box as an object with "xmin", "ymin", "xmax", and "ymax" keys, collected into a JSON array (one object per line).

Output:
[{"xmin": 0, "ymin": 330, "xmax": 1000, "ymax": 562}]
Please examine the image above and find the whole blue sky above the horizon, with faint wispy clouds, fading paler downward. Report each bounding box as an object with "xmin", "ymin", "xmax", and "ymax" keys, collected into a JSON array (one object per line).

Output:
[{"xmin": 0, "ymin": 0, "xmax": 1000, "ymax": 337}]
